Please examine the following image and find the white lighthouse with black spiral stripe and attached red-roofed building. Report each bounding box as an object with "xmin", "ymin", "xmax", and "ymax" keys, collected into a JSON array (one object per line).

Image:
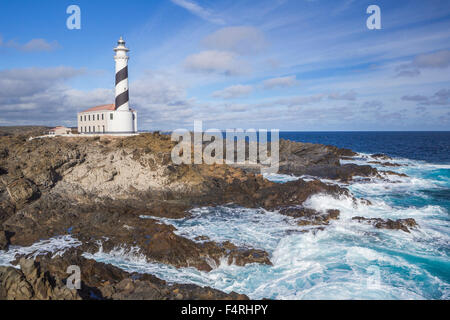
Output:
[{"xmin": 77, "ymin": 37, "xmax": 137, "ymax": 134}]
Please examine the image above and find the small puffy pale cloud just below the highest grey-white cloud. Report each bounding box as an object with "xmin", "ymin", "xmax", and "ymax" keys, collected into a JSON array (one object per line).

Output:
[{"xmin": 184, "ymin": 50, "xmax": 249, "ymax": 75}]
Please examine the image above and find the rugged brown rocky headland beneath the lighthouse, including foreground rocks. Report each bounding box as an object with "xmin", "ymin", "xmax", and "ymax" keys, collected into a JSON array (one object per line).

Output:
[{"xmin": 0, "ymin": 127, "xmax": 416, "ymax": 299}]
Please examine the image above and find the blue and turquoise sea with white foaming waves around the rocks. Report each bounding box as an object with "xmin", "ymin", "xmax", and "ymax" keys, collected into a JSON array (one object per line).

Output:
[{"xmin": 0, "ymin": 132, "xmax": 450, "ymax": 300}]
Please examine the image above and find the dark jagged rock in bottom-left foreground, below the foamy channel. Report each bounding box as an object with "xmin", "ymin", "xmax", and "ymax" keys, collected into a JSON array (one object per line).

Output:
[{"xmin": 11, "ymin": 249, "xmax": 248, "ymax": 300}]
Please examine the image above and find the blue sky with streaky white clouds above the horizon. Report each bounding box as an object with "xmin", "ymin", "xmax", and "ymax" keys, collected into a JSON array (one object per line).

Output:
[{"xmin": 0, "ymin": 0, "xmax": 450, "ymax": 131}]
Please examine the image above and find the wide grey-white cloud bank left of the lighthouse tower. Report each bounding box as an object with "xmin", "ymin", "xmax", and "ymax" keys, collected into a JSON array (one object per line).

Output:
[{"xmin": 0, "ymin": 66, "xmax": 114, "ymax": 125}]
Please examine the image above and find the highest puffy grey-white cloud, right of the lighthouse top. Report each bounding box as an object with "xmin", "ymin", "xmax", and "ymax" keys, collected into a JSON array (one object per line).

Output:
[{"xmin": 203, "ymin": 26, "xmax": 267, "ymax": 54}]
